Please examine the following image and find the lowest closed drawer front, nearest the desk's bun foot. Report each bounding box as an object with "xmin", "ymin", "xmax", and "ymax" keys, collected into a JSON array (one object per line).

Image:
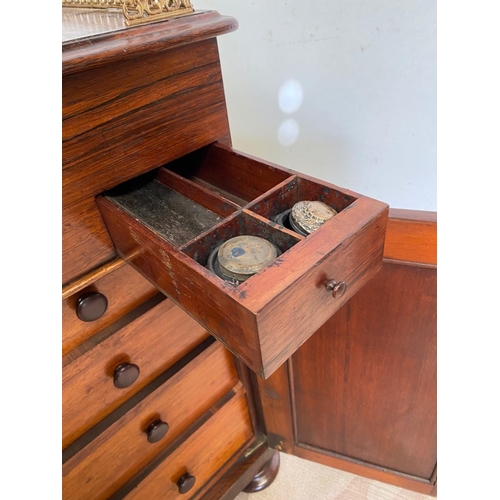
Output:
[{"xmin": 125, "ymin": 391, "xmax": 253, "ymax": 500}]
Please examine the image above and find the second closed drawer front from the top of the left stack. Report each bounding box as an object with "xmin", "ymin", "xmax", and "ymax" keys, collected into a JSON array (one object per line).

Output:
[{"xmin": 62, "ymin": 296, "xmax": 208, "ymax": 448}]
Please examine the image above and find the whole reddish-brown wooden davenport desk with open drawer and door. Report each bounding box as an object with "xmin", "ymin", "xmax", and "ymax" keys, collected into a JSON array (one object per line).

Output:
[{"xmin": 62, "ymin": 9, "xmax": 436, "ymax": 500}]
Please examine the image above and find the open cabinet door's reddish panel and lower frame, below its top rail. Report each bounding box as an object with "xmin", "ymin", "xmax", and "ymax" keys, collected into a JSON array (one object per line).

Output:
[{"xmin": 259, "ymin": 213, "xmax": 436, "ymax": 494}]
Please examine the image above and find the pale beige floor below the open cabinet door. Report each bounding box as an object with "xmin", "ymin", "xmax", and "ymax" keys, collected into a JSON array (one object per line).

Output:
[{"xmin": 236, "ymin": 453, "xmax": 434, "ymax": 500}]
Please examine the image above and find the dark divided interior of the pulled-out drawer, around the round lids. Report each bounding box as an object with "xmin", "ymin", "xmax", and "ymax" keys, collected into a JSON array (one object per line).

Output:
[{"xmin": 100, "ymin": 143, "xmax": 356, "ymax": 286}]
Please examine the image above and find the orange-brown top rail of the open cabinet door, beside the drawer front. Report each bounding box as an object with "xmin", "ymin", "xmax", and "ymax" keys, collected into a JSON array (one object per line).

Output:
[{"xmin": 384, "ymin": 209, "xmax": 437, "ymax": 265}]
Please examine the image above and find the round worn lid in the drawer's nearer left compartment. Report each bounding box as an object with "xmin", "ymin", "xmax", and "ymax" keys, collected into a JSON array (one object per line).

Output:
[{"xmin": 217, "ymin": 235, "xmax": 279, "ymax": 280}]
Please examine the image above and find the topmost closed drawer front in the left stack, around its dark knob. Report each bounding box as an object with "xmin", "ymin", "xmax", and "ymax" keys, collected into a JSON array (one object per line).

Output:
[{"xmin": 62, "ymin": 259, "xmax": 158, "ymax": 356}]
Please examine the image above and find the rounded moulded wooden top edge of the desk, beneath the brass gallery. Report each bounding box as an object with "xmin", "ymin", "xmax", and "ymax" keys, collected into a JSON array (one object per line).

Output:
[{"xmin": 62, "ymin": 11, "xmax": 238, "ymax": 75}]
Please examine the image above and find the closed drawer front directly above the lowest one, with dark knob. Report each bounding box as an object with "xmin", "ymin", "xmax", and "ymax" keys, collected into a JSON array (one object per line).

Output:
[{"xmin": 63, "ymin": 343, "xmax": 239, "ymax": 500}]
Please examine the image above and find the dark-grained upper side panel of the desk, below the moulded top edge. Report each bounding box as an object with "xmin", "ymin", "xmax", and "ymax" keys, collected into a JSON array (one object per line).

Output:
[{"xmin": 62, "ymin": 39, "xmax": 229, "ymax": 283}]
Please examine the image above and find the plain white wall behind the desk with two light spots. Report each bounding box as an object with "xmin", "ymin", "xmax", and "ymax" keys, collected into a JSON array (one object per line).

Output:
[{"xmin": 193, "ymin": 0, "xmax": 436, "ymax": 210}]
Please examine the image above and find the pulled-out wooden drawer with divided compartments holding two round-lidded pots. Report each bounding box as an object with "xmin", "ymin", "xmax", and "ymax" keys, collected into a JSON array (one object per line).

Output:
[{"xmin": 97, "ymin": 143, "xmax": 388, "ymax": 378}]
